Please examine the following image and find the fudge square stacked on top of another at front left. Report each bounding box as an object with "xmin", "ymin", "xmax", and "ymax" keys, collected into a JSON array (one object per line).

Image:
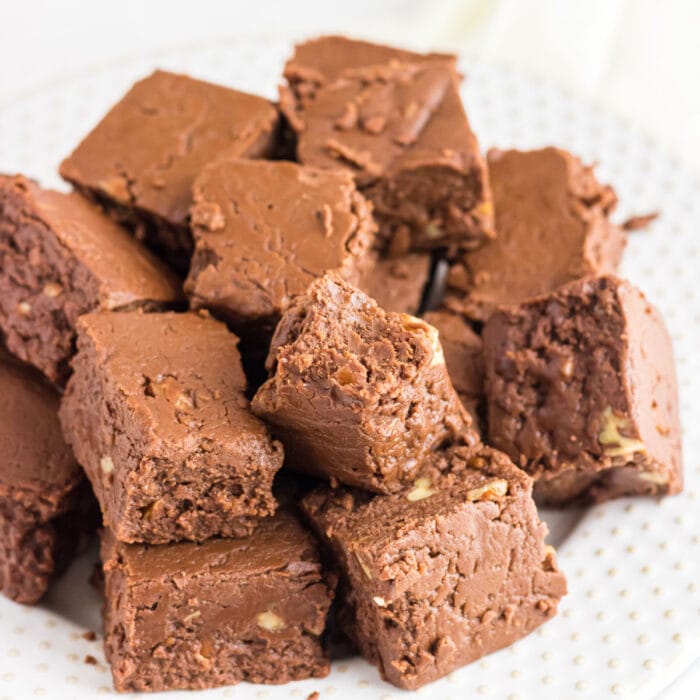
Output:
[{"xmin": 60, "ymin": 312, "xmax": 283, "ymax": 543}]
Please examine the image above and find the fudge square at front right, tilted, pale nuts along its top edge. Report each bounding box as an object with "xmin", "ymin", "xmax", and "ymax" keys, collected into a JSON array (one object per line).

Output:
[{"xmin": 302, "ymin": 447, "xmax": 566, "ymax": 689}]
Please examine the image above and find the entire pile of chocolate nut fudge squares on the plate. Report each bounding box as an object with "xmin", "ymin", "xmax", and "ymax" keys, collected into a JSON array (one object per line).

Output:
[{"xmin": 0, "ymin": 31, "xmax": 682, "ymax": 691}]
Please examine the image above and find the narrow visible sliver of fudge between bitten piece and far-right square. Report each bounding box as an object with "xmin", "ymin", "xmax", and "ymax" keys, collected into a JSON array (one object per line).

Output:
[{"xmin": 423, "ymin": 309, "xmax": 484, "ymax": 429}]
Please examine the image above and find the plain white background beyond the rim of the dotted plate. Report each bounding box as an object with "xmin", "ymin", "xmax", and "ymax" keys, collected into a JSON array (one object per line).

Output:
[{"xmin": 0, "ymin": 0, "xmax": 700, "ymax": 700}]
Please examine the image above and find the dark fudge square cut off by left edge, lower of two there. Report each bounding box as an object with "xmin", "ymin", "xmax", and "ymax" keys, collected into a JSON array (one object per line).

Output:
[{"xmin": 0, "ymin": 349, "xmax": 84, "ymax": 603}]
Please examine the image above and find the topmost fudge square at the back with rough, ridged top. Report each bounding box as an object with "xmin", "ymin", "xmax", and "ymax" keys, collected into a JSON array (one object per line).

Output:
[{"xmin": 280, "ymin": 36, "xmax": 493, "ymax": 253}]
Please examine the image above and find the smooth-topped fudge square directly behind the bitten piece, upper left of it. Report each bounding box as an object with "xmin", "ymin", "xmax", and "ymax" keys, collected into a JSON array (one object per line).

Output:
[{"xmin": 185, "ymin": 160, "xmax": 376, "ymax": 336}]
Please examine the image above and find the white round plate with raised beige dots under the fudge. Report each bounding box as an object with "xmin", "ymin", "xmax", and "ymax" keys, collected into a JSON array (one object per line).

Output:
[{"xmin": 0, "ymin": 31, "xmax": 700, "ymax": 700}]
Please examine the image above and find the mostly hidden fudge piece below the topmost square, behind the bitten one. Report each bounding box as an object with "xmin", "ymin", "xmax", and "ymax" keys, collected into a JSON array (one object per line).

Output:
[{"xmin": 357, "ymin": 253, "xmax": 432, "ymax": 315}]
